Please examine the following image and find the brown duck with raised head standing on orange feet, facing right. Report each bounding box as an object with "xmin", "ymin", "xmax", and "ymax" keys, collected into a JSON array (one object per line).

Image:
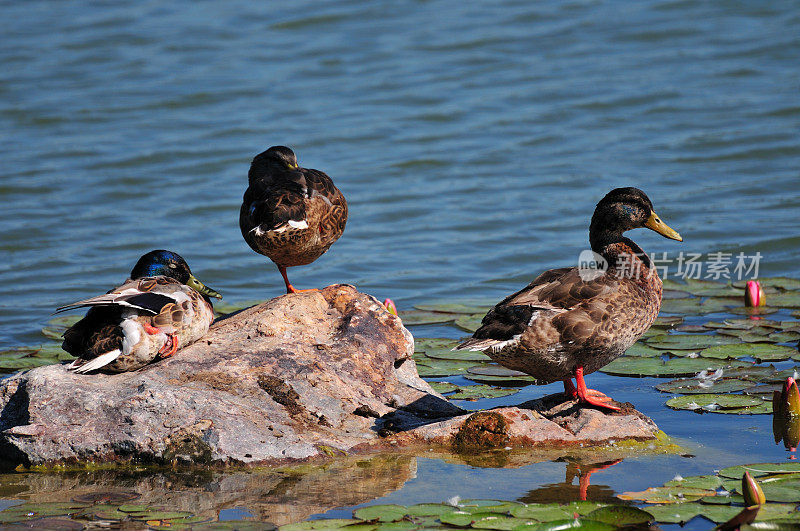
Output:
[{"xmin": 456, "ymin": 188, "xmax": 683, "ymax": 410}]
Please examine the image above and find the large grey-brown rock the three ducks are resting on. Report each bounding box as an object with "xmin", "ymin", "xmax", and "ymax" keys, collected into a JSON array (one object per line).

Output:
[{"xmin": 0, "ymin": 285, "xmax": 657, "ymax": 465}]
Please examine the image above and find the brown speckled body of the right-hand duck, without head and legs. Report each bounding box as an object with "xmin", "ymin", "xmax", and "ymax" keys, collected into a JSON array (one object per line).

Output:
[{"xmin": 458, "ymin": 268, "xmax": 650, "ymax": 381}]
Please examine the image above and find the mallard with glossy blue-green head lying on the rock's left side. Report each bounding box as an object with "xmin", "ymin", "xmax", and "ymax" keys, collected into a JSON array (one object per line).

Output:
[{"xmin": 56, "ymin": 249, "xmax": 222, "ymax": 373}]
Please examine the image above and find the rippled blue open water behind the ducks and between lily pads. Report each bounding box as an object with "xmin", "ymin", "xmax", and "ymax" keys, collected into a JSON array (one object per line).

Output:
[{"xmin": 0, "ymin": 0, "xmax": 800, "ymax": 528}]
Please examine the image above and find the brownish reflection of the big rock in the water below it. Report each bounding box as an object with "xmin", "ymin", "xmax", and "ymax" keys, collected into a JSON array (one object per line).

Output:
[{"xmin": 0, "ymin": 455, "xmax": 417, "ymax": 525}]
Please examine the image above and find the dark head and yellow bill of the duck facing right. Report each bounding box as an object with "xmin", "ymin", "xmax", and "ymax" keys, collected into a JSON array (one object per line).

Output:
[{"xmin": 589, "ymin": 187, "xmax": 683, "ymax": 252}]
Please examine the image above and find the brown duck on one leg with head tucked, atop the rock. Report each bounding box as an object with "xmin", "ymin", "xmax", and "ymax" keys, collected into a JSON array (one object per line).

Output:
[{"xmin": 239, "ymin": 146, "xmax": 347, "ymax": 293}]
